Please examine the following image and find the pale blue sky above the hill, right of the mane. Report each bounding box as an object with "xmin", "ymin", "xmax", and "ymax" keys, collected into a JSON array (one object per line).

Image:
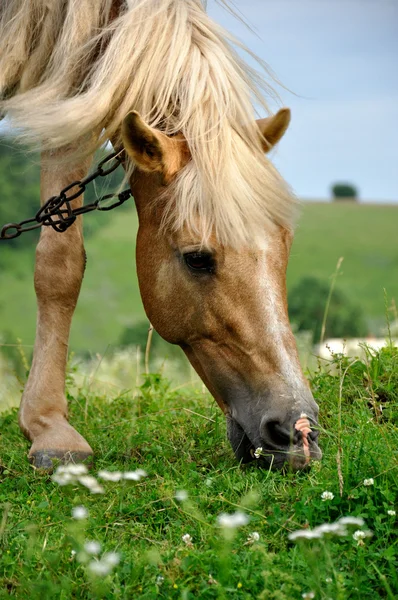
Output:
[{"xmin": 208, "ymin": 0, "xmax": 398, "ymax": 202}]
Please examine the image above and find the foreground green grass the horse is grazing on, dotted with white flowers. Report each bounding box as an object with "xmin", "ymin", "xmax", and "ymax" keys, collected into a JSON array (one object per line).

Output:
[{"xmin": 0, "ymin": 348, "xmax": 398, "ymax": 600}]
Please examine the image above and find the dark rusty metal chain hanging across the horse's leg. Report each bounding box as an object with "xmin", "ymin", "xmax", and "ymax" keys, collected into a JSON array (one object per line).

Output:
[{"xmin": 0, "ymin": 152, "xmax": 132, "ymax": 240}]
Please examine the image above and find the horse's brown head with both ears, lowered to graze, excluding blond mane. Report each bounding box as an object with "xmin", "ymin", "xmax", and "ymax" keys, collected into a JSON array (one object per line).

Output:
[{"xmin": 123, "ymin": 109, "xmax": 321, "ymax": 469}]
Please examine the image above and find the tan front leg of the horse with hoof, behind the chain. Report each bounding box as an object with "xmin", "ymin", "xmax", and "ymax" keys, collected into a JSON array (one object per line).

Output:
[{"xmin": 19, "ymin": 154, "xmax": 92, "ymax": 469}]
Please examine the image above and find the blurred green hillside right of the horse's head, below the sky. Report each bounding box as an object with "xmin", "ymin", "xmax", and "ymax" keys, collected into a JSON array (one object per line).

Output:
[{"xmin": 288, "ymin": 202, "xmax": 398, "ymax": 333}]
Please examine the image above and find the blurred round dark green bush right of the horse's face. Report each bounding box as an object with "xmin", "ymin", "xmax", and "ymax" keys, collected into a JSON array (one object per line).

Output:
[{"xmin": 289, "ymin": 277, "xmax": 367, "ymax": 342}]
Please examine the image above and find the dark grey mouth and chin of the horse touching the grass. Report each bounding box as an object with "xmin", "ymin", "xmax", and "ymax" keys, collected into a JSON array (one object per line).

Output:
[{"xmin": 227, "ymin": 415, "xmax": 322, "ymax": 471}]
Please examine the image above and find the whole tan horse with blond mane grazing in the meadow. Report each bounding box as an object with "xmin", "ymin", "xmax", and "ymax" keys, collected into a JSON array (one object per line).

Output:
[{"xmin": 0, "ymin": 0, "xmax": 321, "ymax": 470}]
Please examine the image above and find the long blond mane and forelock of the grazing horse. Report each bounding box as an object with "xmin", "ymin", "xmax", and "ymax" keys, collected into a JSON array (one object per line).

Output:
[{"xmin": 0, "ymin": 0, "xmax": 295, "ymax": 245}]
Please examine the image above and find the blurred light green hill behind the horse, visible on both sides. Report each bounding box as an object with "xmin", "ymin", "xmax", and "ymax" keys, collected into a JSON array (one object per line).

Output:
[{"xmin": 0, "ymin": 203, "xmax": 398, "ymax": 353}]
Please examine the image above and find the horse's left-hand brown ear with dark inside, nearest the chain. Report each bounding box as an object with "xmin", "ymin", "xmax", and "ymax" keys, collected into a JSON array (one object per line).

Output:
[{"xmin": 122, "ymin": 111, "xmax": 189, "ymax": 183}]
